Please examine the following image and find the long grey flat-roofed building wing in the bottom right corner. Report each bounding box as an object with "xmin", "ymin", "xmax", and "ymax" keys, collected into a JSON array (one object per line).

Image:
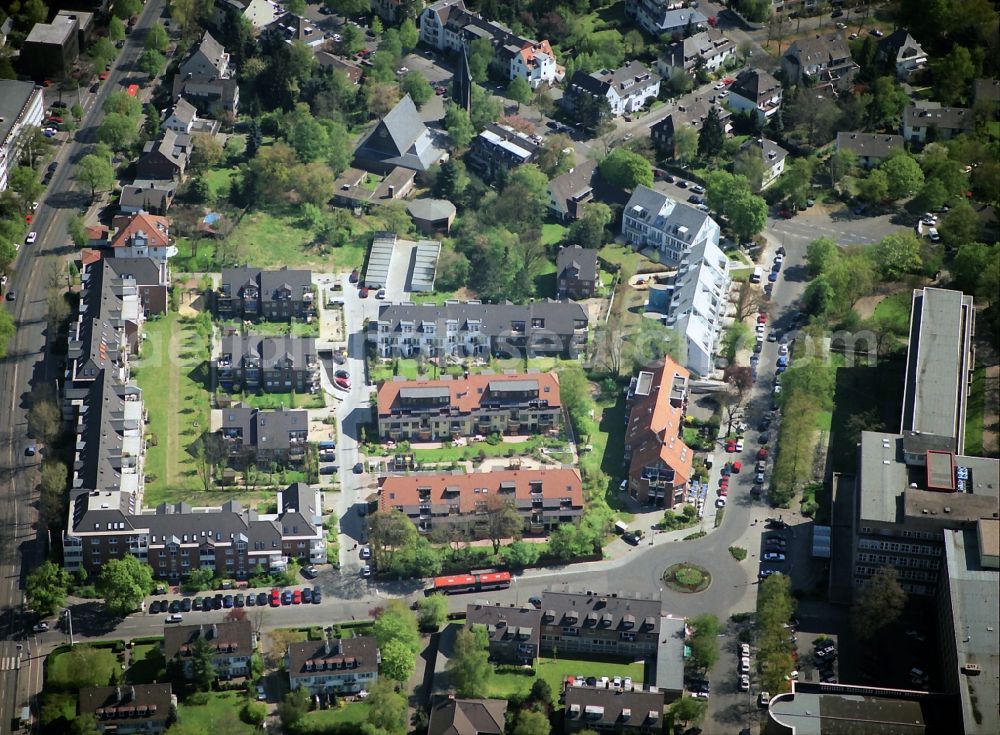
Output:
[{"xmin": 938, "ymin": 517, "xmax": 1000, "ymax": 735}]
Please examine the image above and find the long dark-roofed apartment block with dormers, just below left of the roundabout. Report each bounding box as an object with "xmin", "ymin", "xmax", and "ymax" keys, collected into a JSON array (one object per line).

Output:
[{"xmin": 536, "ymin": 592, "xmax": 661, "ymax": 661}]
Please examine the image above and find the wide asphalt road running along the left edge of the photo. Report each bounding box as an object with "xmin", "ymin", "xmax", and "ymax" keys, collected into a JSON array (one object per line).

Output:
[{"xmin": 0, "ymin": 0, "xmax": 164, "ymax": 729}]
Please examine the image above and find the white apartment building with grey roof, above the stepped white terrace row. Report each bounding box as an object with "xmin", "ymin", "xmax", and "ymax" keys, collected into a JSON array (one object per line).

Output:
[{"xmin": 622, "ymin": 184, "xmax": 720, "ymax": 265}]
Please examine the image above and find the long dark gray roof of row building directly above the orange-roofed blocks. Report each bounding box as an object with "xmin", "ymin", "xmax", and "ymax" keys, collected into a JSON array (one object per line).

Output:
[{"xmin": 378, "ymin": 301, "xmax": 587, "ymax": 337}]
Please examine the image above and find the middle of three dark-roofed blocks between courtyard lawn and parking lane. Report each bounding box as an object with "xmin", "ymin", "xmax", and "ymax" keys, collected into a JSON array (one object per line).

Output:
[{"xmin": 214, "ymin": 335, "xmax": 320, "ymax": 394}]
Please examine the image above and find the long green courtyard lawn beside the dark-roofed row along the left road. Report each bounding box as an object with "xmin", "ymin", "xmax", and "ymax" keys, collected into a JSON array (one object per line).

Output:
[{"xmin": 132, "ymin": 314, "xmax": 210, "ymax": 506}]
